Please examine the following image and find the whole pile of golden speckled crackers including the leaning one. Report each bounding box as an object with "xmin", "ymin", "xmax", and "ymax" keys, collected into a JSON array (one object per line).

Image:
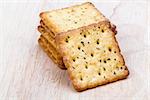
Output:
[{"xmin": 38, "ymin": 2, "xmax": 129, "ymax": 91}]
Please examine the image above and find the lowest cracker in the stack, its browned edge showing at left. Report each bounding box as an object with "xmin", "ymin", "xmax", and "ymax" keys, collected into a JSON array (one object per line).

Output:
[{"xmin": 38, "ymin": 35, "xmax": 65, "ymax": 69}]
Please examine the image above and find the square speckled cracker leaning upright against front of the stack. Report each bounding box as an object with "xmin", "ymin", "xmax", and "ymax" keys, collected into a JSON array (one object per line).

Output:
[{"xmin": 56, "ymin": 22, "xmax": 129, "ymax": 91}]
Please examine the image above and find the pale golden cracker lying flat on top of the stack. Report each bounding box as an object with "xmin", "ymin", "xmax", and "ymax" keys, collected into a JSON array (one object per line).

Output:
[{"xmin": 40, "ymin": 2, "xmax": 111, "ymax": 34}]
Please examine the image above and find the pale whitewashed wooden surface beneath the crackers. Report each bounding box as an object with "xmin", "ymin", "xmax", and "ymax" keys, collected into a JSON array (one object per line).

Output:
[{"xmin": 0, "ymin": 0, "xmax": 150, "ymax": 100}]
